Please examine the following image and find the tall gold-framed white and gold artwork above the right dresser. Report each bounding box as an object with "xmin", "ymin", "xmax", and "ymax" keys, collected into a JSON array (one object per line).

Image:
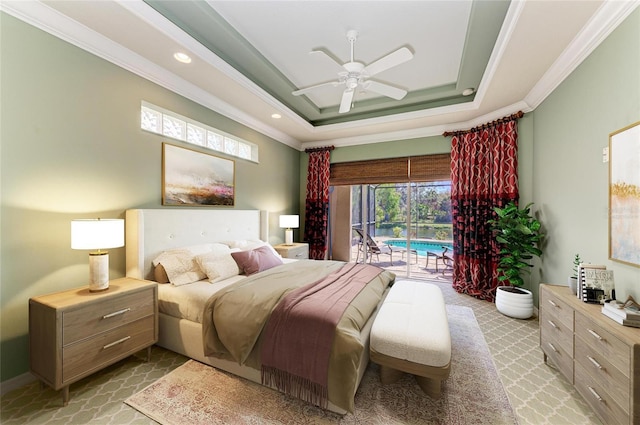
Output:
[{"xmin": 609, "ymin": 121, "xmax": 640, "ymax": 267}]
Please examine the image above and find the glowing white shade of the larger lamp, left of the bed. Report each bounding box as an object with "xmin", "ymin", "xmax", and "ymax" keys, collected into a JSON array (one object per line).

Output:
[{"xmin": 71, "ymin": 219, "xmax": 124, "ymax": 249}]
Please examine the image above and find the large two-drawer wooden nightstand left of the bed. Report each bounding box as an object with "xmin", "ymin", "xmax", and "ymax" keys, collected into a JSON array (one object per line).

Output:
[{"xmin": 29, "ymin": 278, "xmax": 158, "ymax": 406}]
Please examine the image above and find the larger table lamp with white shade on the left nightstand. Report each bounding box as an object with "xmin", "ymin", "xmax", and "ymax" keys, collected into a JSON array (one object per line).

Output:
[{"xmin": 71, "ymin": 218, "xmax": 124, "ymax": 292}]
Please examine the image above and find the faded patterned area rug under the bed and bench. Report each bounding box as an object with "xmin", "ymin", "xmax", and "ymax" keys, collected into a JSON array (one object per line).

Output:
[{"xmin": 125, "ymin": 305, "xmax": 517, "ymax": 425}]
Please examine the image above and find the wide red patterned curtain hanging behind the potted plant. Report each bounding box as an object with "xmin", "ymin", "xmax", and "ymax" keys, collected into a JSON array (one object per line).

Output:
[{"xmin": 445, "ymin": 112, "xmax": 522, "ymax": 302}]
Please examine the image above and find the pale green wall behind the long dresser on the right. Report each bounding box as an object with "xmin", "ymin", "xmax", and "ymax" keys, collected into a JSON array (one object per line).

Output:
[{"xmin": 532, "ymin": 9, "xmax": 640, "ymax": 299}]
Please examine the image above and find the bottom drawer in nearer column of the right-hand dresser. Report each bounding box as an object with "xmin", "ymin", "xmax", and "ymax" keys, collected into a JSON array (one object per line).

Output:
[{"xmin": 575, "ymin": 363, "xmax": 630, "ymax": 425}]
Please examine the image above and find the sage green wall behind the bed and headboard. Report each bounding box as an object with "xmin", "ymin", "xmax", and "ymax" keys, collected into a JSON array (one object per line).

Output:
[{"xmin": 0, "ymin": 14, "xmax": 301, "ymax": 381}]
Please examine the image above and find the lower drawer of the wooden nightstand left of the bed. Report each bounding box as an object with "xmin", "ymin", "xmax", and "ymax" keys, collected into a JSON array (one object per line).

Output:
[{"xmin": 62, "ymin": 315, "xmax": 155, "ymax": 384}]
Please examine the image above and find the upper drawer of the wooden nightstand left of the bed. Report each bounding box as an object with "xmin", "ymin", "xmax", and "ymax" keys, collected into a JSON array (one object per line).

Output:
[{"xmin": 62, "ymin": 288, "xmax": 155, "ymax": 345}]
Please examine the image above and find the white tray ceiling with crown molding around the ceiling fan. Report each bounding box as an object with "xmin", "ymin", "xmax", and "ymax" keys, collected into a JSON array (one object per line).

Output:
[{"xmin": 0, "ymin": 0, "xmax": 640, "ymax": 149}]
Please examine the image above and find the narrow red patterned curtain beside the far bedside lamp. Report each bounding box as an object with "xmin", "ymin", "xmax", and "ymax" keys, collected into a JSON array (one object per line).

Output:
[{"xmin": 304, "ymin": 147, "xmax": 333, "ymax": 260}]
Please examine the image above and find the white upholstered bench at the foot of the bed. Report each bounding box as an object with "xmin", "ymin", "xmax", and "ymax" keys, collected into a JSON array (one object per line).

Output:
[{"xmin": 370, "ymin": 280, "xmax": 451, "ymax": 398}]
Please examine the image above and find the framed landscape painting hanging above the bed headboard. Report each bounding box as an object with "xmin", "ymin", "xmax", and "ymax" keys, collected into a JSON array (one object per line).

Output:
[{"xmin": 162, "ymin": 143, "xmax": 235, "ymax": 206}]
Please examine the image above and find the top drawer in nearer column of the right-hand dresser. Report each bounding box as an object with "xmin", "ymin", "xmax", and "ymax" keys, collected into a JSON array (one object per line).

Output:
[{"xmin": 576, "ymin": 311, "xmax": 631, "ymax": 378}]
